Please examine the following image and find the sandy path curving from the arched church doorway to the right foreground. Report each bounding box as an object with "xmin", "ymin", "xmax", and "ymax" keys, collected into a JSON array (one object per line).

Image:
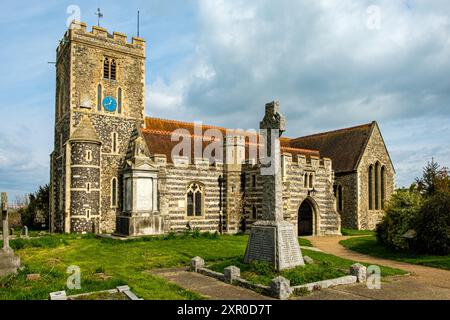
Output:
[{"xmin": 302, "ymin": 236, "xmax": 450, "ymax": 300}]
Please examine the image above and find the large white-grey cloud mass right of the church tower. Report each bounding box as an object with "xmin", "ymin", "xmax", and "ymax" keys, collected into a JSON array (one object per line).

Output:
[{"xmin": 149, "ymin": 0, "xmax": 450, "ymax": 186}]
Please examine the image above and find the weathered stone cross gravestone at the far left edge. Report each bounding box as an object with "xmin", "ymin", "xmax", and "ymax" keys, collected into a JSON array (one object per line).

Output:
[{"xmin": 0, "ymin": 192, "xmax": 20, "ymax": 277}]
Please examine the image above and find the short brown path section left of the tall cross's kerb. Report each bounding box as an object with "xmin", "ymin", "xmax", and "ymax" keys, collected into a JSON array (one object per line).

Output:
[{"xmin": 151, "ymin": 268, "xmax": 270, "ymax": 300}]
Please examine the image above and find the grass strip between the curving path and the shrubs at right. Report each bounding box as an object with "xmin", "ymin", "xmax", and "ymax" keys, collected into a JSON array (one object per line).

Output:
[{"xmin": 340, "ymin": 236, "xmax": 450, "ymax": 270}]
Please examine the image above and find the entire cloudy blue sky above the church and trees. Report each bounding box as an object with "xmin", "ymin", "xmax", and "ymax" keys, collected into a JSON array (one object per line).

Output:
[{"xmin": 0, "ymin": 0, "xmax": 450, "ymax": 199}]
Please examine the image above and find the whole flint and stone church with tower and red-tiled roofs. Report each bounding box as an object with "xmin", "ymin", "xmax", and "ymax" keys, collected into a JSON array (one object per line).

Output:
[{"xmin": 50, "ymin": 22, "xmax": 395, "ymax": 236}]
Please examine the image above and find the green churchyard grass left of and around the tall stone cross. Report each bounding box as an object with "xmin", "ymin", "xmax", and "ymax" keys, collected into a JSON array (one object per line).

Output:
[{"xmin": 0, "ymin": 232, "xmax": 406, "ymax": 300}]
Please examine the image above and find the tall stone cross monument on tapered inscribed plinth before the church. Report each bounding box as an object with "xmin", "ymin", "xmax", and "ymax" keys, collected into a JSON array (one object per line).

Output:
[{"xmin": 245, "ymin": 102, "xmax": 305, "ymax": 270}]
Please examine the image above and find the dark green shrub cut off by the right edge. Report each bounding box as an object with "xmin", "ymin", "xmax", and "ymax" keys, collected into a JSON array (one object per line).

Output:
[{"xmin": 416, "ymin": 193, "xmax": 450, "ymax": 255}]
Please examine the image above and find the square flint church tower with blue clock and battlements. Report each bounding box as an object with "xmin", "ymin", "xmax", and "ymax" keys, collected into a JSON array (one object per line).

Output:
[{"xmin": 50, "ymin": 22, "xmax": 145, "ymax": 232}]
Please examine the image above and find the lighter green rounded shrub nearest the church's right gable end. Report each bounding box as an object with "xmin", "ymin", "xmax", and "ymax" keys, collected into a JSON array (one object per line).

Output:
[{"xmin": 376, "ymin": 190, "xmax": 423, "ymax": 250}]
